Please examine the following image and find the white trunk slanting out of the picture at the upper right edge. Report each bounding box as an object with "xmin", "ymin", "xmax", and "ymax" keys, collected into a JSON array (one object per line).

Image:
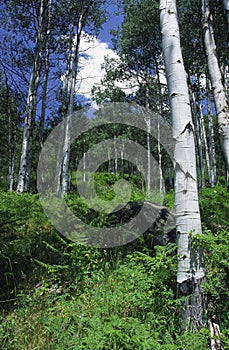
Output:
[{"xmin": 202, "ymin": 0, "xmax": 229, "ymax": 171}]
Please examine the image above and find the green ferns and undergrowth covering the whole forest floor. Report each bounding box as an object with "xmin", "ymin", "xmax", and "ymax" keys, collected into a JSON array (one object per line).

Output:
[{"xmin": 0, "ymin": 179, "xmax": 229, "ymax": 350}]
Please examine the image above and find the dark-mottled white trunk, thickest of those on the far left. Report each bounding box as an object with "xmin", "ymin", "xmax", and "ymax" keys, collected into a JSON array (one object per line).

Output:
[{"xmin": 17, "ymin": 0, "xmax": 48, "ymax": 193}]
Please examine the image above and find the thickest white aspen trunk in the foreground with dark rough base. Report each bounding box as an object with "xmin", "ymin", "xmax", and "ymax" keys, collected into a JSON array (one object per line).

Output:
[{"xmin": 160, "ymin": 0, "xmax": 205, "ymax": 331}]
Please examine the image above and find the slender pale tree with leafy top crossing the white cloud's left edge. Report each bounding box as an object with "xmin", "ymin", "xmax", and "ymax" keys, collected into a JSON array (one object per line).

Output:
[{"xmin": 60, "ymin": 0, "xmax": 105, "ymax": 195}]
